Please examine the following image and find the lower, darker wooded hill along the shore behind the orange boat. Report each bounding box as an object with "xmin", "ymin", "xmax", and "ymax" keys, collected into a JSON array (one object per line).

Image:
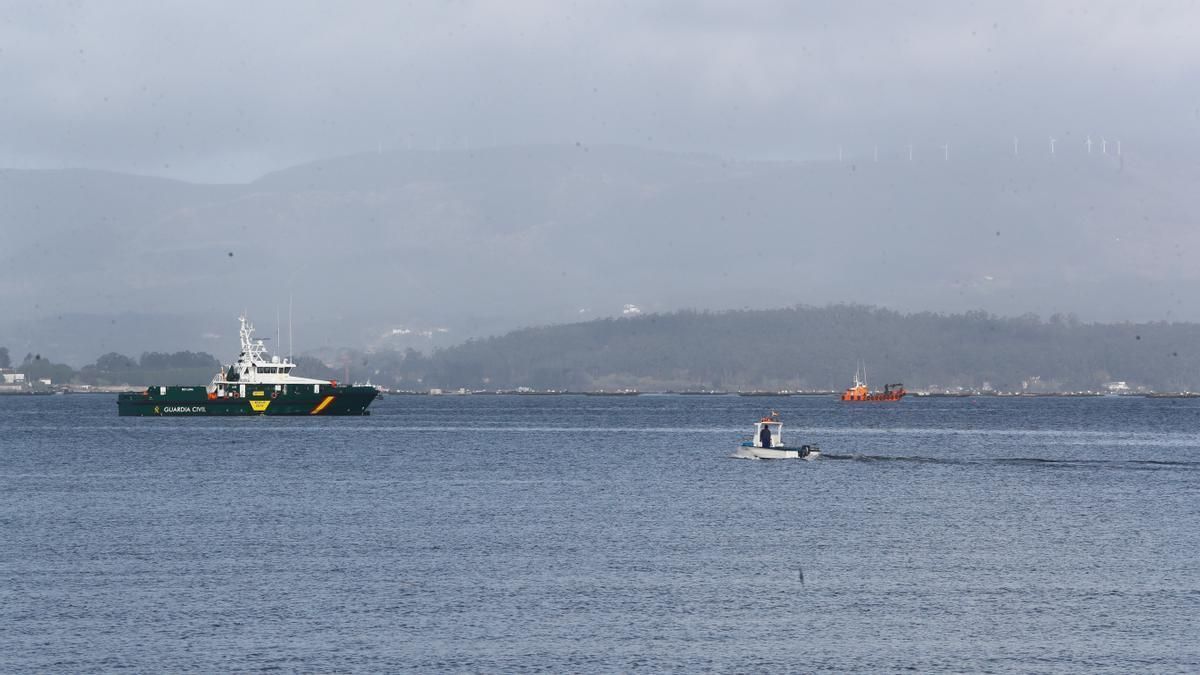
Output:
[{"xmin": 391, "ymin": 305, "xmax": 1200, "ymax": 392}]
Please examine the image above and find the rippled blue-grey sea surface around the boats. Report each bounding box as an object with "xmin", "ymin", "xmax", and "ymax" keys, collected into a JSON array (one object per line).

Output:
[{"xmin": 0, "ymin": 395, "xmax": 1200, "ymax": 673}]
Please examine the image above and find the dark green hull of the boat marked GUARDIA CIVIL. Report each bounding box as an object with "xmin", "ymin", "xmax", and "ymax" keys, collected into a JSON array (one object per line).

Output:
[{"xmin": 116, "ymin": 384, "xmax": 379, "ymax": 417}]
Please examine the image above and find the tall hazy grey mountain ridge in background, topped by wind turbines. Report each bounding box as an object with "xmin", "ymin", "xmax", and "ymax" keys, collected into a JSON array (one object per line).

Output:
[{"xmin": 0, "ymin": 145, "xmax": 1200, "ymax": 363}]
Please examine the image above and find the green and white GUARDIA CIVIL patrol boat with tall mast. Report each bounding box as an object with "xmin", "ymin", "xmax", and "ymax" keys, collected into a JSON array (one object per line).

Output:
[{"xmin": 116, "ymin": 316, "xmax": 379, "ymax": 417}]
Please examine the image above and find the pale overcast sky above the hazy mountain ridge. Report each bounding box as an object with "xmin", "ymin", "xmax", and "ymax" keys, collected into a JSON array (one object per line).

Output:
[{"xmin": 0, "ymin": 0, "xmax": 1200, "ymax": 181}]
